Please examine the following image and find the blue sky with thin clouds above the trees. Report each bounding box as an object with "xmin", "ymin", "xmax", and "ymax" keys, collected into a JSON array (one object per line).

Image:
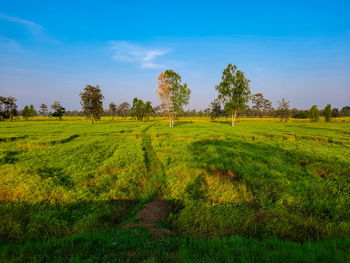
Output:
[{"xmin": 0, "ymin": 0, "xmax": 350, "ymax": 109}]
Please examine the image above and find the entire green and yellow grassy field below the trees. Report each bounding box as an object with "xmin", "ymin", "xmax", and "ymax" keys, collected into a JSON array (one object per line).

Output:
[{"xmin": 0, "ymin": 118, "xmax": 350, "ymax": 262}]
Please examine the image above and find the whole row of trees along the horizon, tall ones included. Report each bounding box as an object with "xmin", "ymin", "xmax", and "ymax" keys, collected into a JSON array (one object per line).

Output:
[{"xmin": 0, "ymin": 64, "xmax": 350, "ymax": 123}]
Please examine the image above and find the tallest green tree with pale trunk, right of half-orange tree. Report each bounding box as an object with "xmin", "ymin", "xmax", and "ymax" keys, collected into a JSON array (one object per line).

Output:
[{"xmin": 215, "ymin": 64, "xmax": 250, "ymax": 127}]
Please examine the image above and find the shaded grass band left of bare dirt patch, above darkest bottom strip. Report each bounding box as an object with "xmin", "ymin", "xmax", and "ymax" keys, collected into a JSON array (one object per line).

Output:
[{"xmin": 0, "ymin": 200, "xmax": 139, "ymax": 241}]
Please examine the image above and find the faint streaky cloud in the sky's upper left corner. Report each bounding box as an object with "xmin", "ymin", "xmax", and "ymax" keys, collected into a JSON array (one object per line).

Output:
[{"xmin": 0, "ymin": 14, "xmax": 60, "ymax": 44}]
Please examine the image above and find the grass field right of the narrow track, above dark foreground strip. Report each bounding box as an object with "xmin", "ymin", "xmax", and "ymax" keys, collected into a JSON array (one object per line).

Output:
[{"xmin": 150, "ymin": 123, "xmax": 350, "ymax": 241}]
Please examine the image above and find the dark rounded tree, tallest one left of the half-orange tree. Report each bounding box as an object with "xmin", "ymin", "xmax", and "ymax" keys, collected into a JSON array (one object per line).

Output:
[{"xmin": 80, "ymin": 85, "xmax": 104, "ymax": 124}]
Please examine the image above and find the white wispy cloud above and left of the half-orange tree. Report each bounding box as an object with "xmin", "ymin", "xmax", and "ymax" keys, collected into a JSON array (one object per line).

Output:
[{"xmin": 110, "ymin": 41, "xmax": 170, "ymax": 68}]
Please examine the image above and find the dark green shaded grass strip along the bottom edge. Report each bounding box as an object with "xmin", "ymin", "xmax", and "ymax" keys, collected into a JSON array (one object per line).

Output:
[{"xmin": 0, "ymin": 228, "xmax": 350, "ymax": 262}]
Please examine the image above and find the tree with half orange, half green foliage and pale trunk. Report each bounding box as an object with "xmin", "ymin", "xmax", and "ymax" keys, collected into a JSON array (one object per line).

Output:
[{"xmin": 156, "ymin": 69, "xmax": 191, "ymax": 127}]
